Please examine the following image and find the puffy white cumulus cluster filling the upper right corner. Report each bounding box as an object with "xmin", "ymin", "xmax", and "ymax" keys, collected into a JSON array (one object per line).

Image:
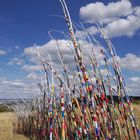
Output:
[{"xmin": 80, "ymin": 0, "xmax": 140, "ymax": 37}]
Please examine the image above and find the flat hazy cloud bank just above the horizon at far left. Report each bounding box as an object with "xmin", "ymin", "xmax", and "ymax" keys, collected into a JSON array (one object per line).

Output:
[{"xmin": 0, "ymin": 78, "xmax": 36, "ymax": 99}]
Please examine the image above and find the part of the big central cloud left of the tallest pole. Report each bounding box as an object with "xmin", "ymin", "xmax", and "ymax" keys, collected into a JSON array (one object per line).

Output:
[{"xmin": 24, "ymin": 40, "xmax": 72, "ymax": 64}]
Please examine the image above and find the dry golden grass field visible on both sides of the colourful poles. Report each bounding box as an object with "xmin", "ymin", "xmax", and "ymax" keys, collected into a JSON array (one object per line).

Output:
[{"xmin": 0, "ymin": 103, "xmax": 140, "ymax": 140}]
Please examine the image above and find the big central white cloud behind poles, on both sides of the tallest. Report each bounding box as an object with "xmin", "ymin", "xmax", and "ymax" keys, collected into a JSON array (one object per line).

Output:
[{"xmin": 22, "ymin": 40, "xmax": 103, "ymax": 71}]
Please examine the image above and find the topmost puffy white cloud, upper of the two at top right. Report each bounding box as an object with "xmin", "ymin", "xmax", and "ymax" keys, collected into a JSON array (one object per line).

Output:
[{"xmin": 80, "ymin": 0, "xmax": 132, "ymax": 23}]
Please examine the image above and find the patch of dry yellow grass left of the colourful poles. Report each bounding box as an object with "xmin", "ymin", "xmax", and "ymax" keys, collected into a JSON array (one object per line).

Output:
[{"xmin": 0, "ymin": 113, "xmax": 29, "ymax": 140}]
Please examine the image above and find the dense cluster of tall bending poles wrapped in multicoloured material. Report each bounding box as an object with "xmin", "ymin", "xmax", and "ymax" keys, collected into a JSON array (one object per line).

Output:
[{"xmin": 11, "ymin": 0, "xmax": 140, "ymax": 140}]
